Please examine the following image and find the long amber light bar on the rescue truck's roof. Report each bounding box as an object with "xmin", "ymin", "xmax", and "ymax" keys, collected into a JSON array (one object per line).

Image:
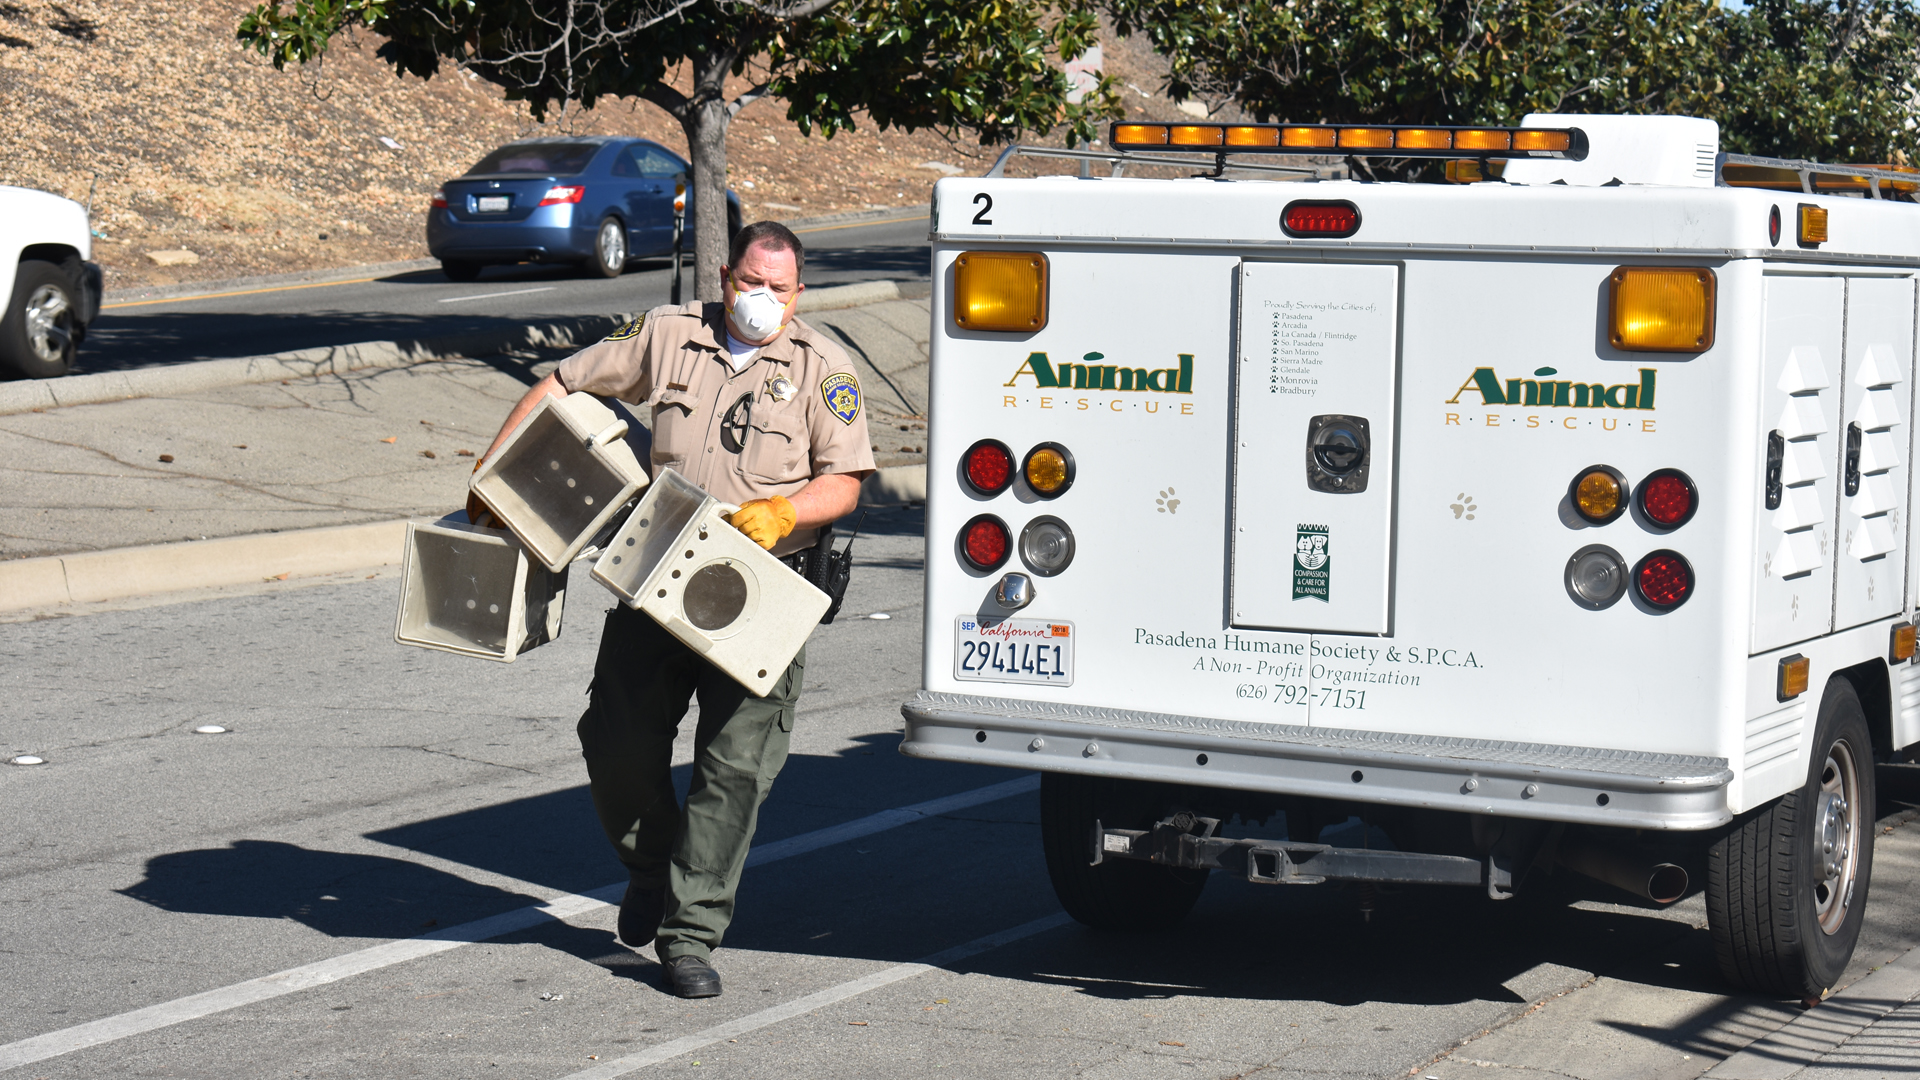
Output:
[{"xmin": 1108, "ymin": 123, "xmax": 1586, "ymax": 161}]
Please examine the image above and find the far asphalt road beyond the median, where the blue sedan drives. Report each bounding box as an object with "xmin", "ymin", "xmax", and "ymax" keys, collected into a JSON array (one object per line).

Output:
[{"xmin": 75, "ymin": 215, "xmax": 929, "ymax": 373}]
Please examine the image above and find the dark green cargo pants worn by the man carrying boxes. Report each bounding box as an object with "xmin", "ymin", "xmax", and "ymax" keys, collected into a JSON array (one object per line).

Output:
[{"xmin": 578, "ymin": 605, "xmax": 806, "ymax": 963}]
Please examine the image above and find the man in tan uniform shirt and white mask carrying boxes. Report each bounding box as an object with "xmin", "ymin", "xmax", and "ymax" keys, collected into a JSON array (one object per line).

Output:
[{"xmin": 476, "ymin": 221, "xmax": 874, "ymax": 997}]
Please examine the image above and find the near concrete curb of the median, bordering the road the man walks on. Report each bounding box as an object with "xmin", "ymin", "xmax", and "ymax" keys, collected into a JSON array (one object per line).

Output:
[{"xmin": 0, "ymin": 465, "xmax": 927, "ymax": 611}]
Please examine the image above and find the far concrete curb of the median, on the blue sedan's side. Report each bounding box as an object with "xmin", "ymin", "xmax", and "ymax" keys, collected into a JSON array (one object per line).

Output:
[{"xmin": 0, "ymin": 281, "xmax": 900, "ymax": 415}]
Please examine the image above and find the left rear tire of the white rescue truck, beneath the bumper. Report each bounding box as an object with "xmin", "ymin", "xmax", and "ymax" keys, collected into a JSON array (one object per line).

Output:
[{"xmin": 1041, "ymin": 773, "xmax": 1208, "ymax": 934}]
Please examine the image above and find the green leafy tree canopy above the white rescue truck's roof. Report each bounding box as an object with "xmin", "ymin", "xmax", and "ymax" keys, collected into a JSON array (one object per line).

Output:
[{"xmin": 1108, "ymin": 0, "xmax": 1920, "ymax": 179}]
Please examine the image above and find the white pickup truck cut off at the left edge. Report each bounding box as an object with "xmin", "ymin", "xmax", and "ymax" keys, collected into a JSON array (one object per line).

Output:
[{"xmin": 0, "ymin": 186, "xmax": 100, "ymax": 379}]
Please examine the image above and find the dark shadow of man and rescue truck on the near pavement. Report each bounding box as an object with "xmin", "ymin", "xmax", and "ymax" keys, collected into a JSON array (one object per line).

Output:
[{"xmin": 125, "ymin": 668, "xmax": 1920, "ymax": 1014}]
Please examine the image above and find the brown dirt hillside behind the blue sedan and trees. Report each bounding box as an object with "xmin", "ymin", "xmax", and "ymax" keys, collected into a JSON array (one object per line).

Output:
[{"xmin": 0, "ymin": 0, "xmax": 1179, "ymax": 288}]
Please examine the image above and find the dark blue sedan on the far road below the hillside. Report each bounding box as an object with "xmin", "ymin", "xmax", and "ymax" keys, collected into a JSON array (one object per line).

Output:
[{"xmin": 426, "ymin": 136, "xmax": 739, "ymax": 281}]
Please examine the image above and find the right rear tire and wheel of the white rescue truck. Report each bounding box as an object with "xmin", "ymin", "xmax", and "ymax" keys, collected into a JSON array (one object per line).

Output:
[{"xmin": 1707, "ymin": 678, "xmax": 1874, "ymax": 999}]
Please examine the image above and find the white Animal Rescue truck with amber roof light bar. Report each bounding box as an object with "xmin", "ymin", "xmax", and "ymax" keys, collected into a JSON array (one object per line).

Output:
[{"xmin": 902, "ymin": 115, "xmax": 1920, "ymax": 997}]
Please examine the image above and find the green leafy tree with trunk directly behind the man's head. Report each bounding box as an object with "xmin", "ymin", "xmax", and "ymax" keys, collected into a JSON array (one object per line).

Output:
[{"xmin": 238, "ymin": 0, "xmax": 1119, "ymax": 300}]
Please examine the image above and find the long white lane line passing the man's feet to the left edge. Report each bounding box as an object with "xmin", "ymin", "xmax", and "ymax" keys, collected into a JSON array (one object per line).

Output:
[{"xmin": 0, "ymin": 774, "xmax": 1041, "ymax": 1072}]
